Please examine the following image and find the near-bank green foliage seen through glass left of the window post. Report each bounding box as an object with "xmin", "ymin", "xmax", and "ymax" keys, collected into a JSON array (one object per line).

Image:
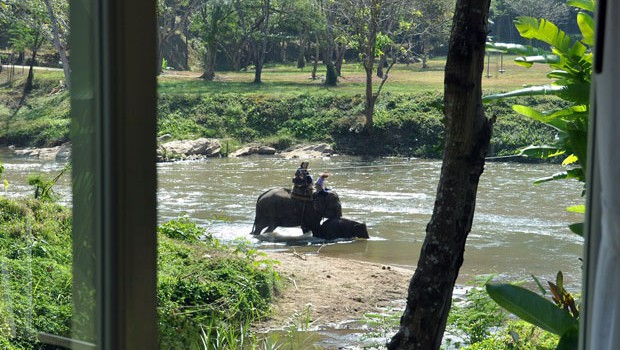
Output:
[{"xmin": 0, "ymin": 197, "xmax": 72, "ymax": 349}]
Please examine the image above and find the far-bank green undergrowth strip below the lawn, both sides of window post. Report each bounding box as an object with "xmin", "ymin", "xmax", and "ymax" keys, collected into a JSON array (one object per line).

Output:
[{"xmin": 0, "ymin": 69, "xmax": 562, "ymax": 158}]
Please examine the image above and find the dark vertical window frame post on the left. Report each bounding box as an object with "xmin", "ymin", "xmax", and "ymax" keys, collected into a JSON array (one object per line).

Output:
[{"xmin": 70, "ymin": 0, "xmax": 158, "ymax": 349}]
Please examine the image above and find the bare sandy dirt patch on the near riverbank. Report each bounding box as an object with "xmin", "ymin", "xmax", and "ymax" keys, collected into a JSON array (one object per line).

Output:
[{"xmin": 254, "ymin": 252, "xmax": 413, "ymax": 329}]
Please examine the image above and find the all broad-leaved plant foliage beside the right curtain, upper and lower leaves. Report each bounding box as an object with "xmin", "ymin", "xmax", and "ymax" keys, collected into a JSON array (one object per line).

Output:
[{"xmin": 486, "ymin": 0, "xmax": 594, "ymax": 349}]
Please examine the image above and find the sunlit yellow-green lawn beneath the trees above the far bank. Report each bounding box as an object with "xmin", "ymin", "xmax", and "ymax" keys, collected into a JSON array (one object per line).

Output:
[{"xmin": 159, "ymin": 55, "xmax": 549, "ymax": 96}]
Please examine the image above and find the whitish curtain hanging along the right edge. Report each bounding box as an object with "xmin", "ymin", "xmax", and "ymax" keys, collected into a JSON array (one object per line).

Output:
[{"xmin": 581, "ymin": 0, "xmax": 620, "ymax": 350}]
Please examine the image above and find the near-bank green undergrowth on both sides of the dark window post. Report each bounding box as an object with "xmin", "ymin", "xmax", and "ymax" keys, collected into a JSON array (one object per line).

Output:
[{"xmin": 0, "ymin": 196, "xmax": 278, "ymax": 349}]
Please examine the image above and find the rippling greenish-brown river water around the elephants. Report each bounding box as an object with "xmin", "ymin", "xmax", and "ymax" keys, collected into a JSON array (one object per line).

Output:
[{"xmin": 0, "ymin": 150, "xmax": 583, "ymax": 291}]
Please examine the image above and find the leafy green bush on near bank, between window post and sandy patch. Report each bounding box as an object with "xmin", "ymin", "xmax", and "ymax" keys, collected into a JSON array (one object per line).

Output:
[{"xmin": 157, "ymin": 218, "xmax": 277, "ymax": 349}]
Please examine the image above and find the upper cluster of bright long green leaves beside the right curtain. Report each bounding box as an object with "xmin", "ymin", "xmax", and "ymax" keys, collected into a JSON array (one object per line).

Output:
[{"xmin": 484, "ymin": 0, "xmax": 594, "ymax": 182}]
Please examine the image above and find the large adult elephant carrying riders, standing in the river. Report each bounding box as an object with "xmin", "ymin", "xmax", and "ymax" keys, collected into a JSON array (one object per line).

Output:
[{"xmin": 250, "ymin": 188, "xmax": 342, "ymax": 235}]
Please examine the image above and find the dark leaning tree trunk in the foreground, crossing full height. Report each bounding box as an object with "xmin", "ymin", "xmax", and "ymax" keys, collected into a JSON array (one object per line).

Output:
[{"xmin": 388, "ymin": 0, "xmax": 492, "ymax": 350}]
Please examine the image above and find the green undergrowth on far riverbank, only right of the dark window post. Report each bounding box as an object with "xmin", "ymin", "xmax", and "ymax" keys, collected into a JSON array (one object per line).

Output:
[{"xmin": 158, "ymin": 92, "xmax": 561, "ymax": 158}]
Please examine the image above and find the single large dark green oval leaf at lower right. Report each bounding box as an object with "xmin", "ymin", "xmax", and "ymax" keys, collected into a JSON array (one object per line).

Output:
[{"xmin": 486, "ymin": 284, "xmax": 579, "ymax": 336}]
